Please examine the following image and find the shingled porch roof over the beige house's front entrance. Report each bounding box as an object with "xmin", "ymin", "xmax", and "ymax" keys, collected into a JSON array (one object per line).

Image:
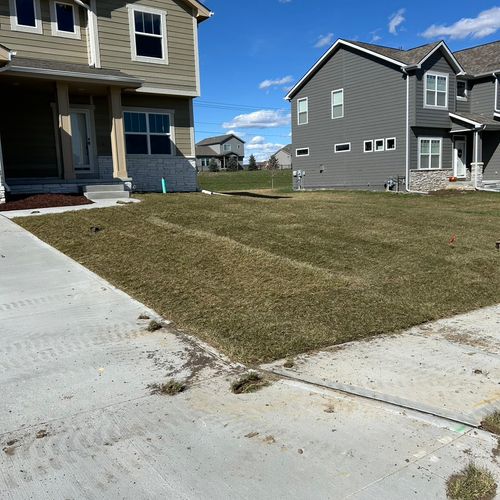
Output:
[{"xmin": 5, "ymin": 57, "xmax": 142, "ymax": 88}]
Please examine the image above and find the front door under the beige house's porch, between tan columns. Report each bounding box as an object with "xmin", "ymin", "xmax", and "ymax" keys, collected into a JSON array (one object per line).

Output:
[{"xmin": 71, "ymin": 109, "xmax": 94, "ymax": 173}]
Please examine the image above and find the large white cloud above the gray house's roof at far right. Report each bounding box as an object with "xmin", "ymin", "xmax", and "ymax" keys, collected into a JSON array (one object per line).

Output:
[{"xmin": 422, "ymin": 7, "xmax": 500, "ymax": 39}]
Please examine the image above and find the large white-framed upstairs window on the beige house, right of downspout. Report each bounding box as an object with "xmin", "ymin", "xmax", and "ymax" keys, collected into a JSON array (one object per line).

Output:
[{"xmin": 129, "ymin": 7, "xmax": 168, "ymax": 64}]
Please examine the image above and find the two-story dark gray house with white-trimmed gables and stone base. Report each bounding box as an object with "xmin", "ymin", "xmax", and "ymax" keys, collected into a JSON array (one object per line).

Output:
[{"xmin": 286, "ymin": 40, "xmax": 500, "ymax": 192}]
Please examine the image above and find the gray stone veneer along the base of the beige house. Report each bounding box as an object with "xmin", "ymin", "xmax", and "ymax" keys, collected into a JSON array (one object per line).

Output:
[{"xmin": 98, "ymin": 155, "xmax": 198, "ymax": 193}]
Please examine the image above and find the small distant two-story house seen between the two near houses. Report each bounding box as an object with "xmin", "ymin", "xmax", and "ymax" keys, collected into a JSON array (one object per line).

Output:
[{"xmin": 196, "ymin": 134, "xmax": 245, "ymax": 172}]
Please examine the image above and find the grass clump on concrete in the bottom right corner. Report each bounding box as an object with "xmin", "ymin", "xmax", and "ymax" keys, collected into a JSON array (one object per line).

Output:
[{"xmin": 446, "ymin": 463, "xmax": 497, "ymax": 500}]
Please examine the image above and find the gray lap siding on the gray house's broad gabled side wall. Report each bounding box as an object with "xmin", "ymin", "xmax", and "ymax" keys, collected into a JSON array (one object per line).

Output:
[{"xmin": 292, "ymin": 48, "xmax": 406, "ymax": 189}]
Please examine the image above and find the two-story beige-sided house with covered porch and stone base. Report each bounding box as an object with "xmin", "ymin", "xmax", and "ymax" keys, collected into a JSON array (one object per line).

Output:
[{"xmin": 0, "ymin": 0, "xmax": 212, "ymax": 201}]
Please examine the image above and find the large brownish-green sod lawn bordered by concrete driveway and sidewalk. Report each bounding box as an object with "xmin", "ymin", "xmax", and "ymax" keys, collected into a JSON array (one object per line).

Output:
[{"xmin": 16, "ymin": 192, "xmax": 500, "ymax": 363}]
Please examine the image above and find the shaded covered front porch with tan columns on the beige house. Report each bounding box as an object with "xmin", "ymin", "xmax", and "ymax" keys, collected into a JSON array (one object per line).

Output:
[{"xmin": 0, "ymin": 58, "xmax": 141, "ymax": 199}]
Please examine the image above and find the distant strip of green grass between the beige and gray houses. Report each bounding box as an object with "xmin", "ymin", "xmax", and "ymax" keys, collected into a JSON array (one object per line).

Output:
[{"xmin": 198, "ymin": 170, "xmax": 292, "ymax": 192}]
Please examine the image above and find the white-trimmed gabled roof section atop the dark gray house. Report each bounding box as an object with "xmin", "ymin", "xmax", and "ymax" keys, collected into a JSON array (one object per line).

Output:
[{"xmin": 285, "ymin": 39, "xmax": 464, "ymax": 100}]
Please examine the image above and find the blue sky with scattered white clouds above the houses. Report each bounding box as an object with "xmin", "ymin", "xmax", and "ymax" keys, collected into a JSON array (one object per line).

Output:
[{"xmin": 195, "ymin": 0, "xmax": 500, "ymax": 159}]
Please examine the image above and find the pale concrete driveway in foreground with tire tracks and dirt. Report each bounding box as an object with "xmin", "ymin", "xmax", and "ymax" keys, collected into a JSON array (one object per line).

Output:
[{"xmin": 0, "ymin": 217, "xmax": 500, "ymax": 500}]
